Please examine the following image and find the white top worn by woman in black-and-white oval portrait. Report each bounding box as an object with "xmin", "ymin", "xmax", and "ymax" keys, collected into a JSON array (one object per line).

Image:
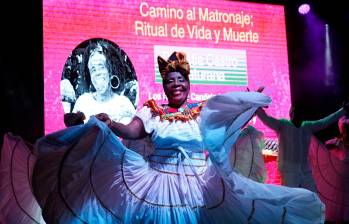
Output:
[{"xmin": 73, "ymin": 93, "xmax": 136, "ymax": 124}]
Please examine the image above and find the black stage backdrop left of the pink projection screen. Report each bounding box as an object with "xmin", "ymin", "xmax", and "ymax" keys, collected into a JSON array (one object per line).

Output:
[{"xmin": 0, "ymin": 0, "xmax": 44, "ymax": 145}]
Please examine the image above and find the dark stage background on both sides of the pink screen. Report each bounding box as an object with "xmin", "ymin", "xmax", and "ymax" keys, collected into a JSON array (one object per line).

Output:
[{"xmin": 0, "ymin": 0, "xmax": 349, "ymax": 146}]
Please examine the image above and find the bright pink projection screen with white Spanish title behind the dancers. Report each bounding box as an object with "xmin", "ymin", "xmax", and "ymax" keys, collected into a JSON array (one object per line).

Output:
[{"xmin": 43, "ymin": 0, "xmax": 290, "ymax": 138}]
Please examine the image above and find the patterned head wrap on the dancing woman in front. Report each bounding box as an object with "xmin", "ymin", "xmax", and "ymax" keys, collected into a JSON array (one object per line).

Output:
[{"xmin": 158, "ymin": 52, "xmax": 190, "ymax": 79}]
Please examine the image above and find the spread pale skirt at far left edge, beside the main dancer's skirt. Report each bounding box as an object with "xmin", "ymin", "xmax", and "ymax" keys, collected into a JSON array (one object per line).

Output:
[{"xmin": 0, "ymin": 133, "xmax": 45, "ymax": 224}]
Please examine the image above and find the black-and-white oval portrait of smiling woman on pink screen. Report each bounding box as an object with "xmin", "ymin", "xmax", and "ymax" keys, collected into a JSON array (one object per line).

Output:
[{"xmin": 60, "ymin": 38, "xmax": 139, "ymax": 124}]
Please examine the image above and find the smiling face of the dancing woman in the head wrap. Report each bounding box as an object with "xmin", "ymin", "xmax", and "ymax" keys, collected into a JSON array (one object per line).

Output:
[{"xmin": 163, "ymin": 72, "xmax": 190, "ymax": 108}]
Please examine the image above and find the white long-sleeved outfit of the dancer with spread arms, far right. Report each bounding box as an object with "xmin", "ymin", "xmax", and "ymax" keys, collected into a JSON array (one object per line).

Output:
[{"xmin": 257, "ymin": 109, "xmax": 344, "ymax": 192}]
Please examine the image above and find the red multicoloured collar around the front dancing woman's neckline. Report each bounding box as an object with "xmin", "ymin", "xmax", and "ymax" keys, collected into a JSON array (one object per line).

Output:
[{"xmin": 144, "ymin": 99, "xmax": 205, "ymax": 122}]
